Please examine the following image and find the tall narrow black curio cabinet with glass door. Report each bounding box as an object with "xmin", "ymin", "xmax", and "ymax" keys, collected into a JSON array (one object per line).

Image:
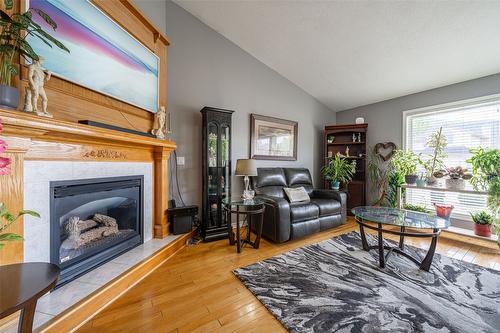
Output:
[{"xmin": 200, "ymin": 107, "xmax": 234, "ymax": 241}]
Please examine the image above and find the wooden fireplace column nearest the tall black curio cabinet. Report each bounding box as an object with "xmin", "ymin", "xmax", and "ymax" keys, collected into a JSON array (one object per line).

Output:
[{"xmin": 153, "ymin": 147, "xmax": 172, "ymax": 238}]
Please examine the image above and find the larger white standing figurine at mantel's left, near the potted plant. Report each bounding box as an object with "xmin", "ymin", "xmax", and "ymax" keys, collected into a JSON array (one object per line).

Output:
[{"xmin": 24, "ymin": 57, "xmax": 52, "ymax": 118}]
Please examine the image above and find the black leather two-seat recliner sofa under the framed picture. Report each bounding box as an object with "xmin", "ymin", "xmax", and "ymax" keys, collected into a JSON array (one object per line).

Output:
[{"xmin": 252, "ymin": 168, "xmax": 347, "ymax": 243}]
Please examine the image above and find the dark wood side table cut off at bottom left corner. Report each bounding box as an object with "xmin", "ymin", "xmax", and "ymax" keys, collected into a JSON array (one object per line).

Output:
[{"xmin": 0, "ymin": 262, "xmax": 60, "ymax": 333}]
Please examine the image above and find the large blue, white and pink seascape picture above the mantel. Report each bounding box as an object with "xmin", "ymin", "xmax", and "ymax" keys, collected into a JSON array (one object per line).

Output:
[{"xmin": 27, "ymin": 0, "xmax": 160, "ymax": 112}]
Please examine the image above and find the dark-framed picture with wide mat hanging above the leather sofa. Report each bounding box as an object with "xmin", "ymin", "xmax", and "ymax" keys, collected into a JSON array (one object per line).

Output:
[{"xmin": 250, "ymin": 113, "xmax": 298, "ymax": 161}]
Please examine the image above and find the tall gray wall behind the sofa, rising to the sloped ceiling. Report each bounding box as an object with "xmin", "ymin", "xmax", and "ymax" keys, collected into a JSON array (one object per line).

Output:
[{"xmin": 135, "ymin": 0, "xmax": 335, "ymax": 205}]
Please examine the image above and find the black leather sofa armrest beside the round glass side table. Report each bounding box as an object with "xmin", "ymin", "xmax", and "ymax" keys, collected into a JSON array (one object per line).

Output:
[{"xmin": 256, "ymin": 195, "xmax": 291, "ymax": 243}]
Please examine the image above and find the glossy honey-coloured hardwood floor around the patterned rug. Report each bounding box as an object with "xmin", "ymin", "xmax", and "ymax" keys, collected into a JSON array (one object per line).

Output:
[{"xmin": 78, "ymin": 220, "xmax": 500, "ymax": 333}]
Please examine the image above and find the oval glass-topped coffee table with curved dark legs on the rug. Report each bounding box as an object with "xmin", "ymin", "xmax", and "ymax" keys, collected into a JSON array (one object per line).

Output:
[{"xmin": 352, "ymin": 206, "xmax": 450, "ymax": 271}]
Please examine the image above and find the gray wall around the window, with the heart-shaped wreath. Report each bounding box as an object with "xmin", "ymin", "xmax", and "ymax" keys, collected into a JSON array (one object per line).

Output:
[{"xmin": 337, "ymin": 74, "xmax": 500, "ymax": 198}]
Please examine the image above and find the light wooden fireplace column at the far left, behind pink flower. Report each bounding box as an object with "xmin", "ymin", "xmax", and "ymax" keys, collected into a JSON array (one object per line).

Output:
[{"xmin": 0, "ymin": 137, "xmax": 30, "ymax": 265}]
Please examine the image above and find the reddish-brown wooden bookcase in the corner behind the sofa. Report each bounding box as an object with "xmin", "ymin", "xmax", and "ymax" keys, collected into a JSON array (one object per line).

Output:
[{"xmin": 324, "ymin": 124, "xmax": 368, "ymax": 215}]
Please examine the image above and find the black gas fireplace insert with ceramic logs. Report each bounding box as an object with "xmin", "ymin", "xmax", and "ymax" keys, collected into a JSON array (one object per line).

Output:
[{"xmin": 50, "ymin": 175, "xmax": 144, "ymax": 285}]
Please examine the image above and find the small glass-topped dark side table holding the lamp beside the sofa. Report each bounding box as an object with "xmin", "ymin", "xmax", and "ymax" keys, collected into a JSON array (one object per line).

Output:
[{"xmin": 222, "ymin": 198, "xmax": 265, "ymax": 253}]
